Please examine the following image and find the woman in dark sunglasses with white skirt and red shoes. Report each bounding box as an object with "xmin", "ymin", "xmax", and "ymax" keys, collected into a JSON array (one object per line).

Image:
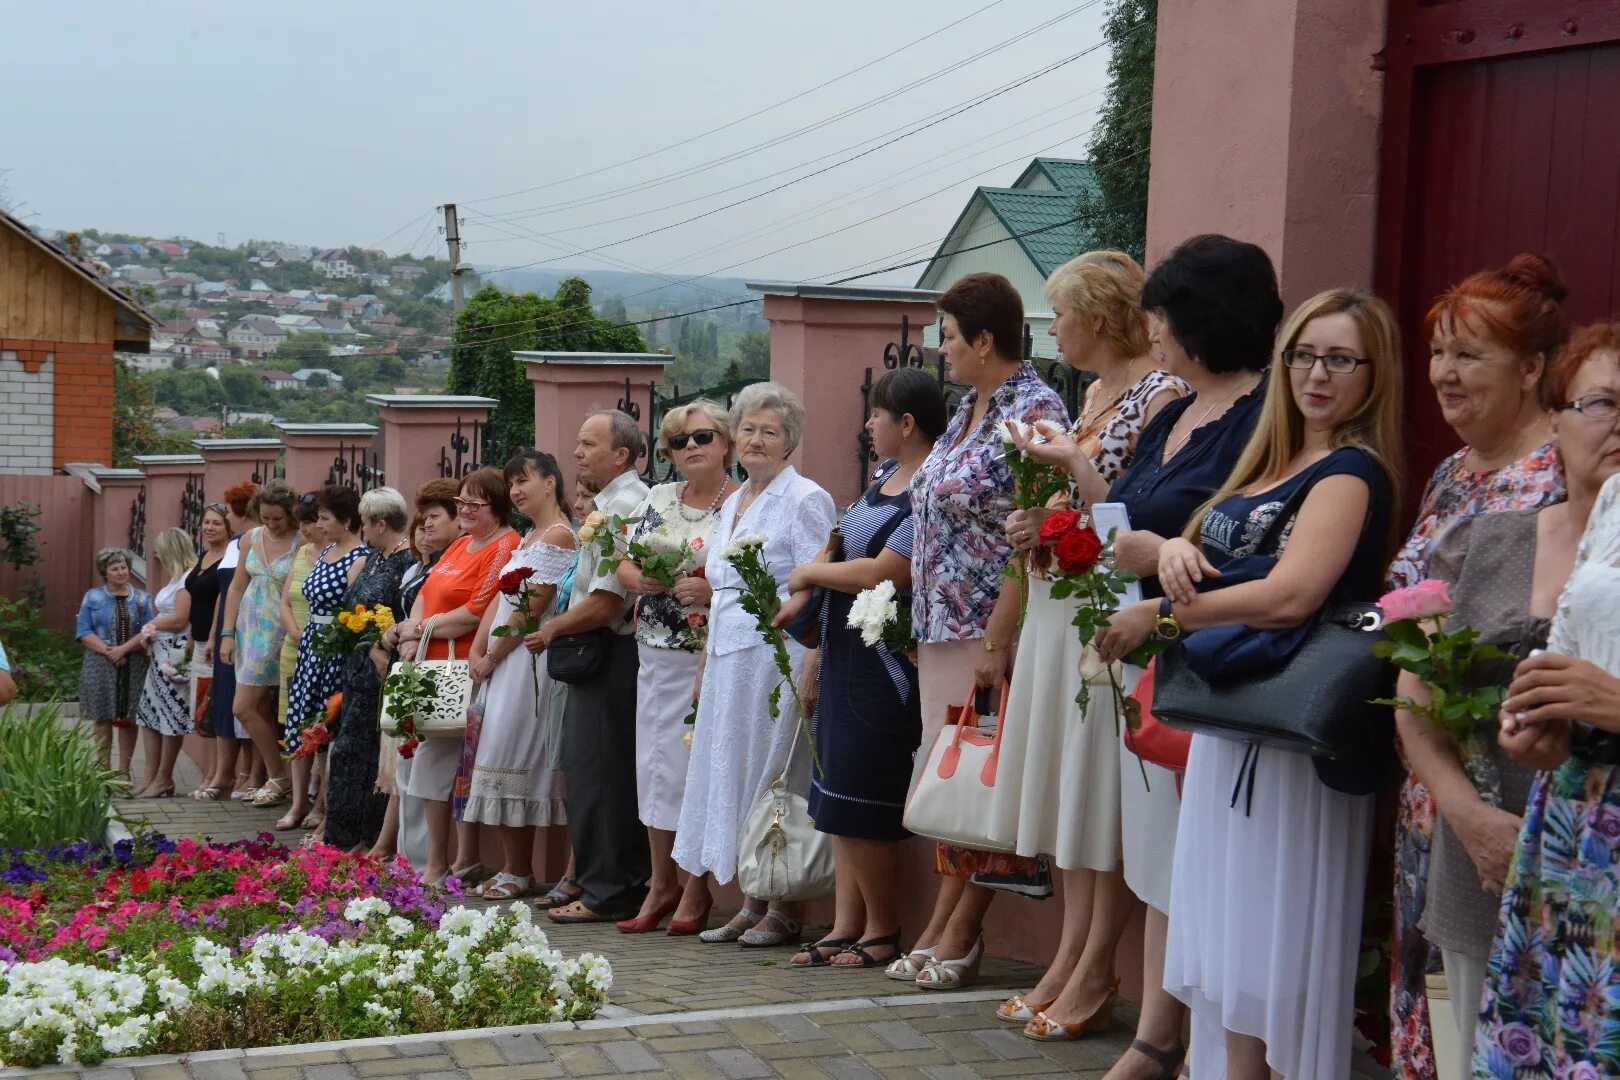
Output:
[{"xmin": 619, "ymin": 398, "xmax": 735, "ymax": 934}]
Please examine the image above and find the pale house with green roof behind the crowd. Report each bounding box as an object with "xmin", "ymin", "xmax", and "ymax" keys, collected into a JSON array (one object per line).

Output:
[{"xmin": 917, "ymin": 157, "xmax": 1095, "ymax": 356}]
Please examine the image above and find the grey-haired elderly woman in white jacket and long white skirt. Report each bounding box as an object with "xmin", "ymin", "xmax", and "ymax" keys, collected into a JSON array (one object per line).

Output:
[{"xmin": 672, "ymin": 382, "xmax": 838, "ymax": 947}]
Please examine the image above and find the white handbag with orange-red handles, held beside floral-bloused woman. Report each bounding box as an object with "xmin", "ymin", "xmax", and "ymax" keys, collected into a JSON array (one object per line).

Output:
[{"xmin": 904, "ymin": 682, "xmax": 1017, "ymax": 852}]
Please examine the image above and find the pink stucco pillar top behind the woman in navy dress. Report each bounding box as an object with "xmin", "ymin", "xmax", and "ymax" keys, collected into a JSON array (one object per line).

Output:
[{"xmin": 748, "ymin": 282, "xmax": 940, "ymax": 505}]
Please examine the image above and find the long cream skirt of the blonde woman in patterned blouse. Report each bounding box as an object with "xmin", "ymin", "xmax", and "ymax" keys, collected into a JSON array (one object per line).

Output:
[{"xmin": 988, "ymin": 578, "xmax": 1119, "ymax": 870}]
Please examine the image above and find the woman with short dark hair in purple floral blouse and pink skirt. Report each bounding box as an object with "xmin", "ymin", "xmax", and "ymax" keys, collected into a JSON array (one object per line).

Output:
[{"xmin": 888, "ymin": 274, "xmax": 1069, "ymax": 989}]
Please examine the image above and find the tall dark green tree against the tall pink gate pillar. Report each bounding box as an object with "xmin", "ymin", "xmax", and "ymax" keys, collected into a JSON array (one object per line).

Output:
[{"xmin": 1076, "ymin": 0, "xmax": 1158, "ymax": 262}]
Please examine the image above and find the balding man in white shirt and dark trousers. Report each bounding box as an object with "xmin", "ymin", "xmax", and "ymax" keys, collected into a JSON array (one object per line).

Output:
[{"xmin": 541, "ymin": 410, "xmax": 650, "ymax": 923}]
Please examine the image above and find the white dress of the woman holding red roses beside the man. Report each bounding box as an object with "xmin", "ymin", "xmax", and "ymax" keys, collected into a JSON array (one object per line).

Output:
[{"xmin": 462, "ymin": 541, "xmax": 573, "ymax": 827}]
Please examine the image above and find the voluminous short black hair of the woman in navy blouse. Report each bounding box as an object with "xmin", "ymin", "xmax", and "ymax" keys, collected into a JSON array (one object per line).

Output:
[{"xmin": 1142, "ymin": 233, "xmax": 1283, "ymax": 376}]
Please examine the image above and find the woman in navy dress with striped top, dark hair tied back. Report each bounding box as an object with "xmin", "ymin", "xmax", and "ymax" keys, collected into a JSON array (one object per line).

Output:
[{"xmin": 774, "ymin": 368, "xmax": 946, "ymax": 967}]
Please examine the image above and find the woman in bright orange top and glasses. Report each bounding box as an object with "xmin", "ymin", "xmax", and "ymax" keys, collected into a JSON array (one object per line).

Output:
[{"xmin": 399, "ymin": 468, "xmax": 518, "ymax": 882}]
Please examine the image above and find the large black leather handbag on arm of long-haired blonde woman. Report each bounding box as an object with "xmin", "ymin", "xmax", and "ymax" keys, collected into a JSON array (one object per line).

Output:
[{"xmin": 1153, "ymin": 459, "xmax": 1396, "ymax": 795}]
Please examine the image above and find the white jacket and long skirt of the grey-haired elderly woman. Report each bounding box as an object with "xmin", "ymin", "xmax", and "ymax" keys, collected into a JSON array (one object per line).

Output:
[{"xmin": 676, "ymin": 466, "xmax": 838, "ymax": 884}]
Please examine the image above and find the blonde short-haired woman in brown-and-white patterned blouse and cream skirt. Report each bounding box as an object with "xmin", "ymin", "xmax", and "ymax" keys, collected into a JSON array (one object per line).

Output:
[{"xmin": 990, "ymin": 251, "xmax": 1187, "ymax": 1040}]
